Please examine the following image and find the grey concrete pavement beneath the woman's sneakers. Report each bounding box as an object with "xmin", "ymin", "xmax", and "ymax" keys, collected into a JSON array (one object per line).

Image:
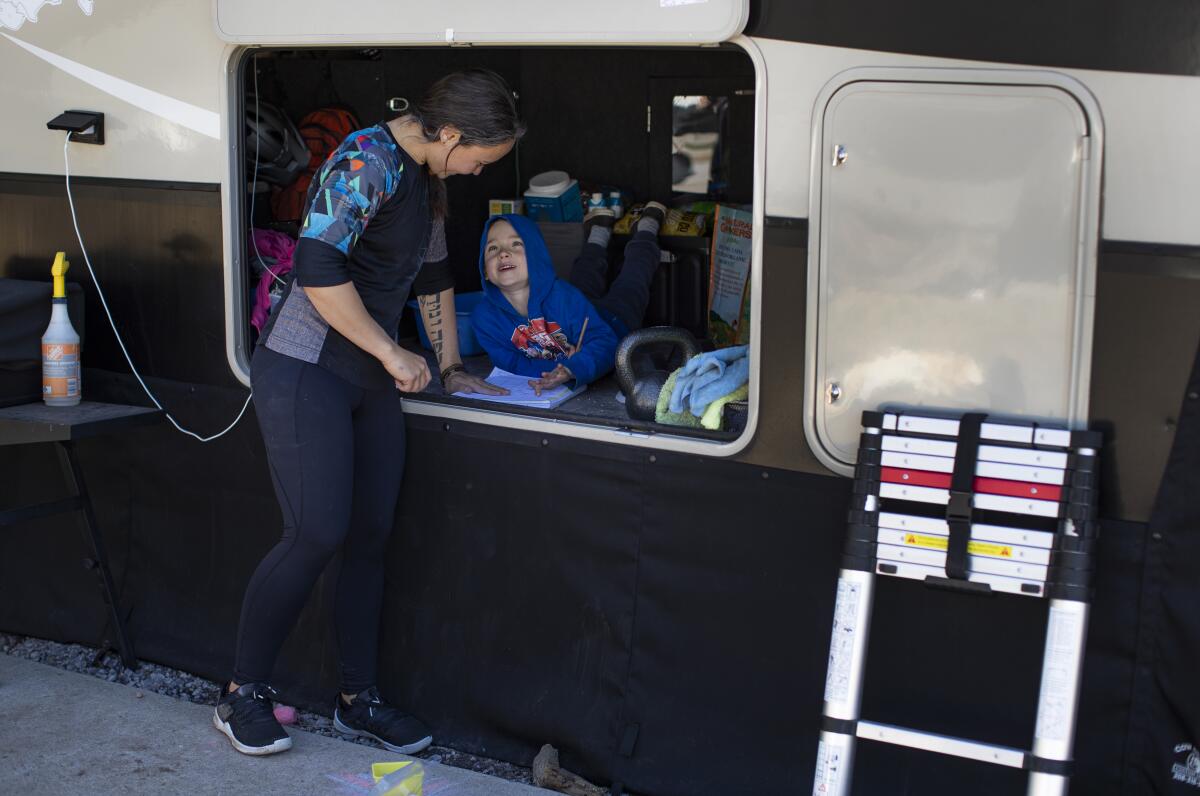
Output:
[{"xmin": 0, "ymin": 654, "xmax": 551, "ymax": 796}]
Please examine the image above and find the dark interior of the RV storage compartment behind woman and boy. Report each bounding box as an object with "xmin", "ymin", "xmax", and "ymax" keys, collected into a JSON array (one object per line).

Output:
[{"xmin": 240, "ymin": 46, "xmax": 755, "ymax": 439}]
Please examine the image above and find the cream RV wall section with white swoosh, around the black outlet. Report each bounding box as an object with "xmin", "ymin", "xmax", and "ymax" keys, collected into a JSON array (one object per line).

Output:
[{"xmin": 0, "ymin": 0, "xmax": 226, "ymax": 182}]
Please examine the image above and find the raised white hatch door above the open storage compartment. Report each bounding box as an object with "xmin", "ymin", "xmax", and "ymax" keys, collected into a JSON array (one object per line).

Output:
[{"xmin": 214, "ymin": 0, "xmax": 749, "ymax": 44}]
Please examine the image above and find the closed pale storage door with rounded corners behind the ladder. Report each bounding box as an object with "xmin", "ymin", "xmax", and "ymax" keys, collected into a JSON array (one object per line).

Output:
[{"xmin": 806, "ymin": 73, "xmax": 1099, "ymax": 472}]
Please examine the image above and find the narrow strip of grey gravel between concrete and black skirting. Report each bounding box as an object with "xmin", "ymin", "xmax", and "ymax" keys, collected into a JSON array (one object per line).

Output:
[{"xmin": 0, "ymin": 633, "xmax": 533, "ymax": 785}]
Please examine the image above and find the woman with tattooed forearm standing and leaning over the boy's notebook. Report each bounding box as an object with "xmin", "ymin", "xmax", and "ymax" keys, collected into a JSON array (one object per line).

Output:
[{"xmin": 212, "ymin": 70, "xmax": 524, "ymax": 755}]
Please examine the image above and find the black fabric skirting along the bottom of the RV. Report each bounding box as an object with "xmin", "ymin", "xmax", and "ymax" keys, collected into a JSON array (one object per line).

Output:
[{"xmin": 0, "ymin": 364, "xmax": 1200, "ymax": 796}]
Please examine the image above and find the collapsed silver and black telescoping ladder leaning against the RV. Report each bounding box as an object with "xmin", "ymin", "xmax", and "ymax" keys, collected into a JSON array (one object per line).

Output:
[{"xmin": 812, "ymin": 412, "xmax": 1100, "ymax": 796}]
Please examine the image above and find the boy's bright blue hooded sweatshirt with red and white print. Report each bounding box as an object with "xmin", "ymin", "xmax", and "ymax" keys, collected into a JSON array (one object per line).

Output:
[{"xmin": 470, "ymin": 215, "xmax": 618, "ymax": 384}]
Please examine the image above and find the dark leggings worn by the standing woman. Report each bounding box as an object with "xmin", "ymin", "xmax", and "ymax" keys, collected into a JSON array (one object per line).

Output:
[{"xmin": 234, "ymin": 346, "xmax": 404, "ymax": 694}]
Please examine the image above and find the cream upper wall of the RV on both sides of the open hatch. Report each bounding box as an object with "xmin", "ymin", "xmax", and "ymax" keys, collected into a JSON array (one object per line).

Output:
[{"xmin": 0, "ymin": 0, "xmax": 1200, "ymax": 245}]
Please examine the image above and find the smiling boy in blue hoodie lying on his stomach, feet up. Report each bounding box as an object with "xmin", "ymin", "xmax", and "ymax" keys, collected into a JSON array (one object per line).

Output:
[{"xmin": 472, "ymin": 202, "xmax": 666, "ymax": 395}]
